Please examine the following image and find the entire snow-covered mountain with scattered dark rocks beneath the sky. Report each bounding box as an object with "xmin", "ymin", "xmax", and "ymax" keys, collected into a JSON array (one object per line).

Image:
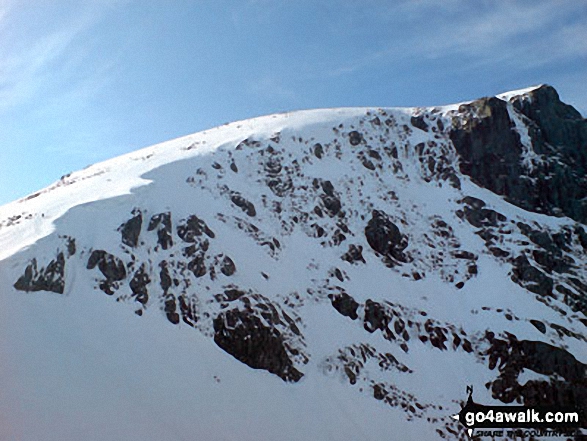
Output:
[{"xmin": 0, "ymin": 86, "xmax": 587, "ymax": 441}]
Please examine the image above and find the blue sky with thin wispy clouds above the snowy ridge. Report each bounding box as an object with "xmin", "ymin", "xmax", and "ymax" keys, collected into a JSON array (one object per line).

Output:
[{"xmin": 0, "ymin": 0, "xmax": 587, "ymax": 204}]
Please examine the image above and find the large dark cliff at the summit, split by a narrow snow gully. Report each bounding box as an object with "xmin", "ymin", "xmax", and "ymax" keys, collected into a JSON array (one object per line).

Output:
[{"xmin": 449, "ymin": 86, "xmax": 587, "ymax": 223}]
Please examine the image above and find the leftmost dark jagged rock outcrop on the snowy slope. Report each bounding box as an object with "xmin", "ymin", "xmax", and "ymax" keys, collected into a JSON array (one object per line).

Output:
[{"xmin": 14, "ymin": 253, "xmax": 65, "ymax": 294}]
